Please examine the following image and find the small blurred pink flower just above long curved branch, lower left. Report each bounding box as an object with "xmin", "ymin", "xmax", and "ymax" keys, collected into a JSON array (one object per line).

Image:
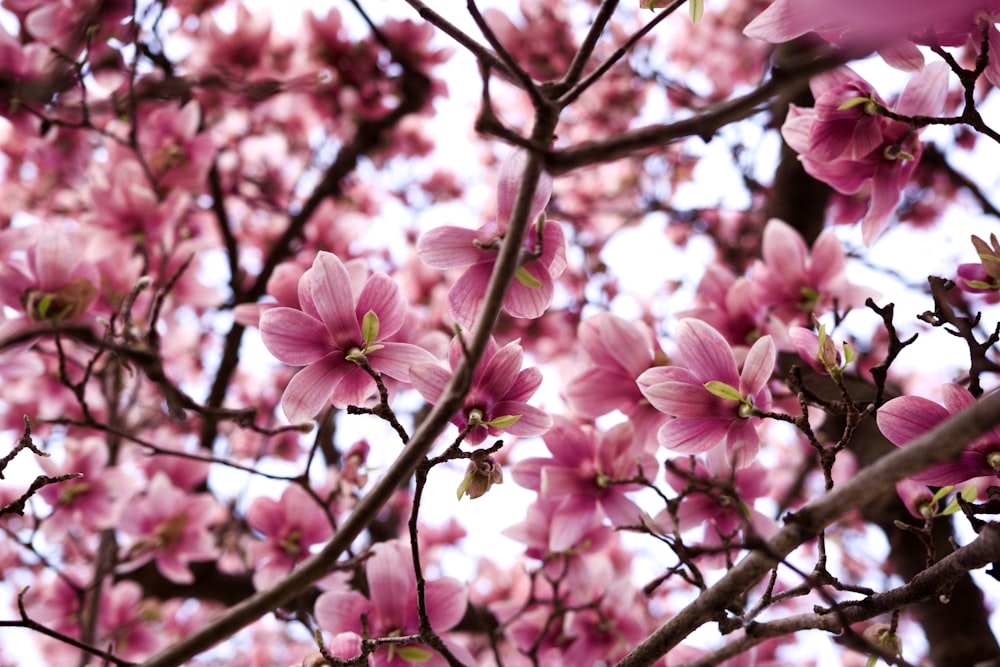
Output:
[{"xmin": 247, "ymin": 484, "xmax": 333, "ymax": 590}]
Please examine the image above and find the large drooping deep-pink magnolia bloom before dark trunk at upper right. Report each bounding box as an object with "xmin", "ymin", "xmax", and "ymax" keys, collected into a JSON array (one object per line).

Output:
[{"xmin": 781, "ymin": 62, "xmax": 950, "ymax": 245}]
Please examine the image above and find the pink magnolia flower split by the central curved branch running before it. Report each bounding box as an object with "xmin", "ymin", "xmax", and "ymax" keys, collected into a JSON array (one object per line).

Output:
[{"xmin": 417, "ymin": 152, "xmax": 566, "ymax": 328}]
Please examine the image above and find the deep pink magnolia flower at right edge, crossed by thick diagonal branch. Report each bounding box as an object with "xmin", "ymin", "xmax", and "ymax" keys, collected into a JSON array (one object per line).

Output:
[{"xmin": 877, "ymin": 384, "xmax": 1000, "ymax": 486}]
